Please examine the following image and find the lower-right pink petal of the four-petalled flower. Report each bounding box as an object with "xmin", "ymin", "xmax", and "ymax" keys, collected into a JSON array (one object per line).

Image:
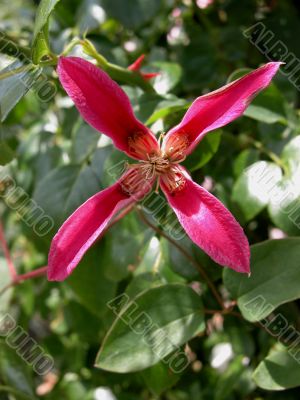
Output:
[{"xmin": 161, "ymin": 170, "xmax": 250, "ymax": 273}]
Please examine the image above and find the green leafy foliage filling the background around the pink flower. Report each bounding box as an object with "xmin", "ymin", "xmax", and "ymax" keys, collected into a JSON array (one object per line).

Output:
[{"xmin": 0, "ymin": 0, "xmax": 300, "ymax": 400}]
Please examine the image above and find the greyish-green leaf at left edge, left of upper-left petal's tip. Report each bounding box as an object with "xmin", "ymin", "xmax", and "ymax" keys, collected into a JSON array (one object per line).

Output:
[{"xmin": 0, "ymin": 61, "xmax": 41, "ymax": 122}]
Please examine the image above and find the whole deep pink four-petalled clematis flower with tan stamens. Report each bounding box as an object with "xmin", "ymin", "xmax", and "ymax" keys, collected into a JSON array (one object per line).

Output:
[{"xmin": 48, "ymin": 57, "xmax": 280, "ymax": 281}]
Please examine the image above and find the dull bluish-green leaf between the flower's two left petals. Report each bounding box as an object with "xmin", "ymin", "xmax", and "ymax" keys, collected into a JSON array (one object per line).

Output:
[{"xmin": 33, "ymin": 165, "xmax": 101, "ymax": 225}]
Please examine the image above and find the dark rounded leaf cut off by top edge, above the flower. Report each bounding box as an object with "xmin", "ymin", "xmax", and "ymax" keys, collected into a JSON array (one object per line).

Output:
[{"xmin": 102, "ymin": 0, "xmax": 162, "ymax": 29}]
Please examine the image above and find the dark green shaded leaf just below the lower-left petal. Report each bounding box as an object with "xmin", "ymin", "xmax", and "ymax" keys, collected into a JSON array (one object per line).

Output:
[{"xmin": 67, "ymin": 244, "xmax": 117, "ymax": 316}]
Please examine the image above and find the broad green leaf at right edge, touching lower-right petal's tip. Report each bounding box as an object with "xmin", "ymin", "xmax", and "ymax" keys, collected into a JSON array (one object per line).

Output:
[{"xmin": 223, "ymin": 238, "xmax": 300, "ymax": 322}]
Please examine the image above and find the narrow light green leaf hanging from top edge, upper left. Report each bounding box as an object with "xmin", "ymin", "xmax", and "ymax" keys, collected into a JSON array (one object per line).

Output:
[{"xmin": 32, "ymin": 0, "xmax": 59, "ymax": 64}]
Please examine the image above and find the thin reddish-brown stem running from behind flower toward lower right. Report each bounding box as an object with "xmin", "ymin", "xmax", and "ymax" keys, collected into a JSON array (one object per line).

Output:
[{"xmin": 136, "ymin": 208, "xmax": 225, "ymax": 312}]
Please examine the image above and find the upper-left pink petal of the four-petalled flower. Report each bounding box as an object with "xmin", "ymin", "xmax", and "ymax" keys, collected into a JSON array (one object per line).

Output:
[{"xmin": 57, "ymin": 57, "xmax": 158, "ymax": 158}]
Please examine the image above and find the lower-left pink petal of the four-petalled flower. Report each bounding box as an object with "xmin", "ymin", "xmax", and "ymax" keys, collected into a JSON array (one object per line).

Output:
[{"xmin": 48, "ymin": 170, "xmax": 153, "ymax": 281}]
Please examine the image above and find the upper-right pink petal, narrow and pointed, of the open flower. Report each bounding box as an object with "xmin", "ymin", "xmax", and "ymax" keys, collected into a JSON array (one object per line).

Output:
[{"xmin": 163, "ymin": 62, "xmax": 282, "ymax": 154}]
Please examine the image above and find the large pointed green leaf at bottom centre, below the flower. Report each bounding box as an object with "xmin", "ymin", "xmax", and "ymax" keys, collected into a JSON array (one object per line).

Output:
[{"xmin": 96, "ymin": 284, "xmax": 205, "ymax": 372}]
